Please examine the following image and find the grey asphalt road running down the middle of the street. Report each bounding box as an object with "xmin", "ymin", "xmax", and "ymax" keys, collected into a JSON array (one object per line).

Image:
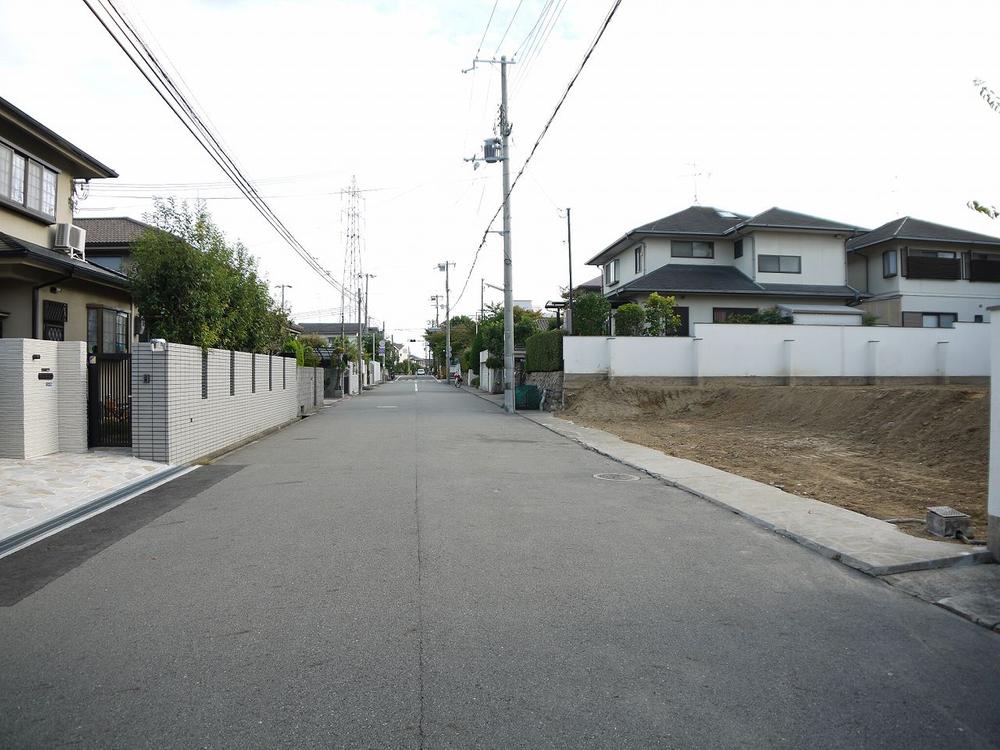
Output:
[{"xmin": 0, "ymin": 380, "xmax": 1000, "ymax": 748}]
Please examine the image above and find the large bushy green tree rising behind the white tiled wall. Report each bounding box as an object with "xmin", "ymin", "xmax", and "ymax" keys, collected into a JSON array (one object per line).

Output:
[{"xmin": 129, "ymin": 199, "xmax": 287, "ymax": 352}]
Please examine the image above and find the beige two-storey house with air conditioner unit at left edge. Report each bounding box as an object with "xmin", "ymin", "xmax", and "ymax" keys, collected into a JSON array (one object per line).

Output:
[{"xmin": 0, "ymin": 94, "xmax": 134, "ymax": 353}]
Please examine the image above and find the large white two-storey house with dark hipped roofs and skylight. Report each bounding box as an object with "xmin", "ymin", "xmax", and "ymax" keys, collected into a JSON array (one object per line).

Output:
[{"xmin": 587, "ymin": 206, "xmax": 862, "ymax": 336}]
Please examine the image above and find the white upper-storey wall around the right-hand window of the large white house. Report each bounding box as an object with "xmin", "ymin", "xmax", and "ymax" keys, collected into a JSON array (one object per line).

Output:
[{"xmin": 744, "ymin": 232, "xmax": 847, "ymax": 285}]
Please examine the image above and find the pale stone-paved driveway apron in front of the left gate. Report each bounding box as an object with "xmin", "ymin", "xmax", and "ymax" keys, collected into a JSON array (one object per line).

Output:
[{"xmin": 0, "ymin": 450, "xmax": 188, "ymax": 557}]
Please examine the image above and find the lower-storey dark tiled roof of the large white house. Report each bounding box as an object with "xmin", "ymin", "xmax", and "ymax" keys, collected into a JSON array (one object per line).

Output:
[{"xmin": 611, "ymin": 263, "xmax": 859, "ymax": 299}]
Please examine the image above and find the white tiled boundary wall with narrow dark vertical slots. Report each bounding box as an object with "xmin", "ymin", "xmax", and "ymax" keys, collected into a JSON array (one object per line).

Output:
[{"xmin": 132, "ymin": 343, "xmax": 323, "ymax": 463}]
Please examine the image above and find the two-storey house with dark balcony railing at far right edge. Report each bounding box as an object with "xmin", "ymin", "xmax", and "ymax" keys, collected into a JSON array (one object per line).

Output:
[{"xmin": 847, "ymin": 216, "xmax": 1000, "ymax": 328}]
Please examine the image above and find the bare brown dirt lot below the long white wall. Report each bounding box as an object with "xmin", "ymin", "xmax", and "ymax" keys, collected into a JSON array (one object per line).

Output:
[{"xmin": 560, "ymin": 383, "xmax": 989, "ymax": 536}]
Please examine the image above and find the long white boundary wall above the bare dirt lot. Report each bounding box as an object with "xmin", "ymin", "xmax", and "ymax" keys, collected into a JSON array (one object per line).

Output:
[{"xmin": 563, "ymin": 323, "xmax": 990, "ymax": 378}]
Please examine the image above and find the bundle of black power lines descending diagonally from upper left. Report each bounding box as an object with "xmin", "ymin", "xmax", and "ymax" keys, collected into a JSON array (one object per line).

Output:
[{"xmin": 83, "ymin": 0, "xmax": 350, "ymax": 300}]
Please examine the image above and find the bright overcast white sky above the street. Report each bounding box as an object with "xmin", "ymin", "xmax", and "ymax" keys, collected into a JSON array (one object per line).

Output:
[{"xmin": 0, "ymin": 0, "xmax": 1000, "ymax": 354}]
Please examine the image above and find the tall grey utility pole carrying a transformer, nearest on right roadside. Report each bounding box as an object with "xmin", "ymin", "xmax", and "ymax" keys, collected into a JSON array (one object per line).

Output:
[{"xmin": 462, "ymin": 56, "xmax": 514, "ymax": 414}]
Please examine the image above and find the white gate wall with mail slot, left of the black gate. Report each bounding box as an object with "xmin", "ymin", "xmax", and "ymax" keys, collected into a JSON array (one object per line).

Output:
[{"xmin": 0, "ymin": 339, "xmax": 87, "ymax": 458}]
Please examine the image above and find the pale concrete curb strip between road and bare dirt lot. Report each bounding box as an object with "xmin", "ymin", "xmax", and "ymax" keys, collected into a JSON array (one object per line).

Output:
[{"xmin": 469, "ymin": 390, "xmax": 993, "ymax": 577}]
